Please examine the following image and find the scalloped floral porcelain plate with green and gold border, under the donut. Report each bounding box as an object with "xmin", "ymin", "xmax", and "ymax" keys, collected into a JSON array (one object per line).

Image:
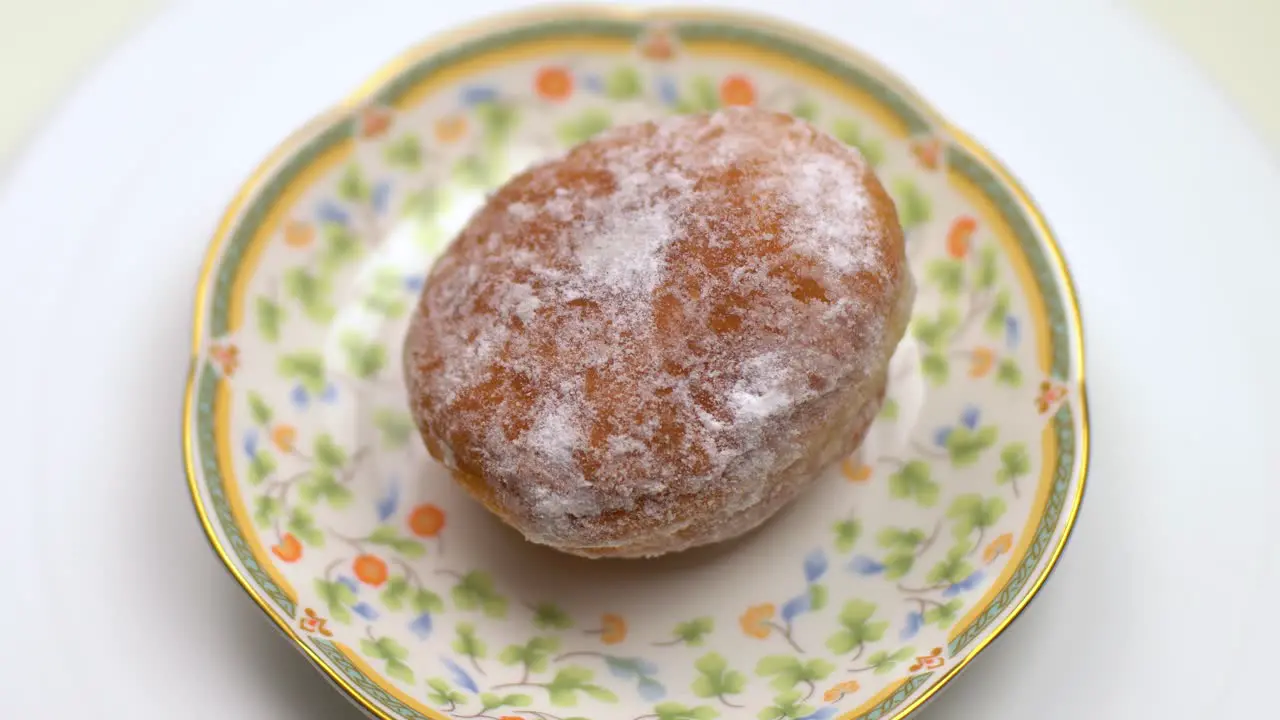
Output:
[{"xmin": 183, "ymin": 9, "xmax": 1088, "ymax": 720}]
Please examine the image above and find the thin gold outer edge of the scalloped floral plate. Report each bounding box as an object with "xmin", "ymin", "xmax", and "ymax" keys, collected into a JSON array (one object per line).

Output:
[{"xmin": 182, "ymin": 4, "xmax": 1091, "ymax": 720}]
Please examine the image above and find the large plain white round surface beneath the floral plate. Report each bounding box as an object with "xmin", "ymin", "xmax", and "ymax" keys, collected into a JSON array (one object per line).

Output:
[{"xmin": 0, "ymin": 0, "xmax": 1280, "ymax": 720}]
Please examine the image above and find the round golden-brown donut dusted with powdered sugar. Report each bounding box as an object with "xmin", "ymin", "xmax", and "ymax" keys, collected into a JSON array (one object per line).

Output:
[{"xmin": 403, "ymin": 108, "xmax": 915, "ymax": 557}]
